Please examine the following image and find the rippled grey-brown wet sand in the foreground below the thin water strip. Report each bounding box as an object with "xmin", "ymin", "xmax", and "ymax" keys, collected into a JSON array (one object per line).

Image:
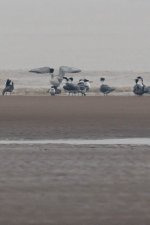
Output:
[{"xmin": 0, "ymin": 145, "xmax": 150, "ymax": 225}]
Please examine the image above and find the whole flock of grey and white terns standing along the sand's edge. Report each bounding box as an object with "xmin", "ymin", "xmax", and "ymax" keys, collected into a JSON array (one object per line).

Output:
[{"xmin": 2, "ymin": 66, "xmax": 150, "ymax": 96}]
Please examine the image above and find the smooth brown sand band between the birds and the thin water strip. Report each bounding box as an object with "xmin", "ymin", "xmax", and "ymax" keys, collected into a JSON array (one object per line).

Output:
[{"xmin": 0, "ymin": 96, "xmax": 150, "ymax": 139}]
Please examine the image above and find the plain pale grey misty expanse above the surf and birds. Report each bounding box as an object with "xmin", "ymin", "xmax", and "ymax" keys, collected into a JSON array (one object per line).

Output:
[{"xmin": 0, "ymin": 0, "xmax": 150, "ymax": 71}]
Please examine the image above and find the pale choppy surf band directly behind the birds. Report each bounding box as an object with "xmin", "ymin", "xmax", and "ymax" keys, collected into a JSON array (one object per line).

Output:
[{"xmin": 0, "ymin": 70, "xmax": 150, "ymax": 96}]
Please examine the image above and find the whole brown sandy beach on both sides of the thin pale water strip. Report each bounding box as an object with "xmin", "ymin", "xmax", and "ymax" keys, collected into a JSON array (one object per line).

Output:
[{"xmin": 0, "ymin": 96, "xmax": 150, "ymax": 225}]
